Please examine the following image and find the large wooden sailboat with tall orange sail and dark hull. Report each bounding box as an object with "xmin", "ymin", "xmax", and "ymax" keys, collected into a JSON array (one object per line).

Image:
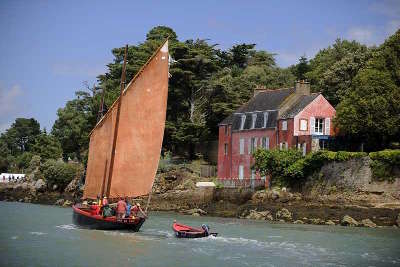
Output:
[{"xmin": 72, "ymin": 39, "xmax": 169, "ymax": 231}]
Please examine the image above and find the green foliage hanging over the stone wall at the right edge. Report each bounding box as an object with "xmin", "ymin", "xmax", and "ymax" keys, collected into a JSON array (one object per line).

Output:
[{"xmin": 369, "ymin": 150, "xmax": 400, "ymax": 182}]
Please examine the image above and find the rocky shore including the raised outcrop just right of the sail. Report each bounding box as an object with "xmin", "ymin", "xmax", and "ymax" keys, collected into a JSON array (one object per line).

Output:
[{"xmin": 0, "ymin": 167, "xmax": 400, "ymax": 227}]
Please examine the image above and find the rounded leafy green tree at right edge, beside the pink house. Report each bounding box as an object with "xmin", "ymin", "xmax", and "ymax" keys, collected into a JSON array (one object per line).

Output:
[{"xmin": 335, "ymin": 68, "xmax": 400, "ymax": 150}]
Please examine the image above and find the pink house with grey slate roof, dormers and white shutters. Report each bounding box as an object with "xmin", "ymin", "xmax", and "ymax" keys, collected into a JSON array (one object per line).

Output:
[{"xmin": 218, "ymin": 81, "xmax": 336, "ymax": 183}]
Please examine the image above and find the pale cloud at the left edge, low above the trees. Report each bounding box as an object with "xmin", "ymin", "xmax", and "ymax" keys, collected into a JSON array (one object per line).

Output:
[{"xmin": 0, "ymin": 85, "xmax": 23, "ymax": 132}]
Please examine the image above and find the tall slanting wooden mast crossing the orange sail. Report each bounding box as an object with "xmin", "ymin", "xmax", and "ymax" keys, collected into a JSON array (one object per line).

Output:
[{"xmin": 106, "ymin": 45, "xmax": 128, "ymax": 197}]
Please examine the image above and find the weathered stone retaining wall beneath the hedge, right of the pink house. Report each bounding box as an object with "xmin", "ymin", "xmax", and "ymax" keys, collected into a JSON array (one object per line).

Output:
[{"xmin": 305, "ymin": 157, "xmax": 400, "ymax": 193}]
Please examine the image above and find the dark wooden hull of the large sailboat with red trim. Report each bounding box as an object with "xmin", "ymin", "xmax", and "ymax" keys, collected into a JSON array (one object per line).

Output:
[{"xmin": 72, "ymin": 205, "xmax": 146, "ymax": 232}]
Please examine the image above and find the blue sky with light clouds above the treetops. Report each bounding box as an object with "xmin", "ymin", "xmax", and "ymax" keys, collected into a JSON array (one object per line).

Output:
[{"xmin": 0, "ymin": 0, "xmax": 400, "ymax": 133}]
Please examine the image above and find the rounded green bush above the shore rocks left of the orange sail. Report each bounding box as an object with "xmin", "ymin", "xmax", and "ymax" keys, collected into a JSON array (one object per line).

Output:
[{"xmin": 40, "ymin": 159, "xmax": 80, "ymax": 190}]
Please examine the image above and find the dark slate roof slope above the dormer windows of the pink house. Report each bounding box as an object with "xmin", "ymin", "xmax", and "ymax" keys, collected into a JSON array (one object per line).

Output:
[{"xmin": 220, "ymin": 87, "xmax": 295, "ymax": 125}]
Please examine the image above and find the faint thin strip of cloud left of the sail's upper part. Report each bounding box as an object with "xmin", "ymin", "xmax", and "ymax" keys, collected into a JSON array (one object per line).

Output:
[{"xmin": 52, "ymin": 62, "xmax": 106, "ymax": 76}]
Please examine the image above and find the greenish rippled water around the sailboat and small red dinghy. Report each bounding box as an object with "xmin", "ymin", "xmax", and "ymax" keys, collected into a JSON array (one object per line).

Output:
[{"xmin": 0, "ymin": 202, "xmax": 400, "ymax": 267}]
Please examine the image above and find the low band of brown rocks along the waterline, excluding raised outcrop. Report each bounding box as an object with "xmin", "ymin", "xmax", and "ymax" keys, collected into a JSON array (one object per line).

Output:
[{"xmin": 0, "ymin": 185, "xmax": 400, "ymax": 228}]
